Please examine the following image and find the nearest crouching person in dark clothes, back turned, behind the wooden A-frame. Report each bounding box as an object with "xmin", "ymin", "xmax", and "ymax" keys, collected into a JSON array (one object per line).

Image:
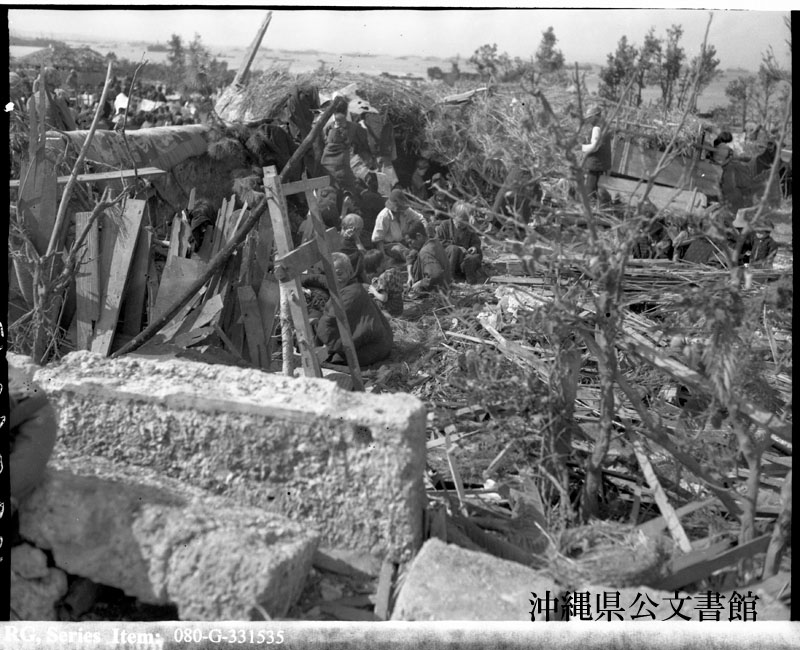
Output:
[{"xmin": 317, "ymin": 253, "xmax": 394, "ymax": 366}]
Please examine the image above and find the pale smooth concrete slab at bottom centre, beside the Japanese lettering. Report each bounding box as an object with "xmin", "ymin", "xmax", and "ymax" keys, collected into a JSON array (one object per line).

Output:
[{"xmin": 391, "ymin": 539, "xmax": 560, "ymax": 621}]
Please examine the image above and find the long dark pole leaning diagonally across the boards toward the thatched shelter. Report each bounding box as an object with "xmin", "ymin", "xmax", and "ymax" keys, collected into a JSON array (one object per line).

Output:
[{"xmin": 111, "ymin": 102, "xmax": 336, "ymax": 359}]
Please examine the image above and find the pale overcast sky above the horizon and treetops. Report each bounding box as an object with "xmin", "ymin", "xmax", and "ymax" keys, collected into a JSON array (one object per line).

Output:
[{"xmin": 8, "ymin": 0, "xmax": 790, "ymax": 69}]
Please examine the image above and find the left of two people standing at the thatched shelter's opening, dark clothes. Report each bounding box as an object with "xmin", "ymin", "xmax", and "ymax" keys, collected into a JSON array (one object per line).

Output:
[{"xmin": 320, "ymin": 104, "xmax": 375, "ymax": 196}]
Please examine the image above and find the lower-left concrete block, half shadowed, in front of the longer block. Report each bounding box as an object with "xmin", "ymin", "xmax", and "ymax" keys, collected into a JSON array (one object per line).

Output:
[{"xmin": 20, "ymin": 458, "xmax": 318, "ymax": 620}]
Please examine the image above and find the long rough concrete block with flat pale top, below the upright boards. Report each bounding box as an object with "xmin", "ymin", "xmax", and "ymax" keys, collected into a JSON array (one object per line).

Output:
[{"xmin": 36, "ymin": 352, "xmax": 425, "ymax": 561}]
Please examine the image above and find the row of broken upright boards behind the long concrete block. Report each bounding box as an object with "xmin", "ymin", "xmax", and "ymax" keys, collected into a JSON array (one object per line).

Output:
[{"xmin": 70, "ymin": 193, "xmax": 278, "ymax": 370}]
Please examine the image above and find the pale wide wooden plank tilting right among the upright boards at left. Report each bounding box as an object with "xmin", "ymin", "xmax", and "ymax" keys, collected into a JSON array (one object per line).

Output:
[{"xmin": 92, "ymin": 199, "xmax": 145, "ymax": 356}]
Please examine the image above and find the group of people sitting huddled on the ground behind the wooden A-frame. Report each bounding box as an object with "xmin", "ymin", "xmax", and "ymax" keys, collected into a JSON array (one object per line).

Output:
[{"xmin": 304, "ymin": 177, "xmax": 483, "ymax": 365}]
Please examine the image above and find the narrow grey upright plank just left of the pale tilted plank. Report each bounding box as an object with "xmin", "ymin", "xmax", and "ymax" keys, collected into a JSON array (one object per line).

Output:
[{"xmin": 75, "ymin": 212, "xmax": 100, "ymax": 350}]
